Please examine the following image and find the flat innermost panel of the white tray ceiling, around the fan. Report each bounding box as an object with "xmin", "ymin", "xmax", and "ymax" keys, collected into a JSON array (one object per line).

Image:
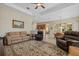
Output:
[{"xmin": 14, "ymin": 3, "xmax": 58, "ymax": 15}]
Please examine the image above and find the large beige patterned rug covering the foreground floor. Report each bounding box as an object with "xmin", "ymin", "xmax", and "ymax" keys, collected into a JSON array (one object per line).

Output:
[{"xmin": 5, "ymin": 40, "xmax": 67, "ymax": 56}]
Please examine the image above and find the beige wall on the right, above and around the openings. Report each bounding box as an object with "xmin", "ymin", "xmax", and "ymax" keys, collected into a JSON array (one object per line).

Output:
[{"xmin": 36, "ymin": 17, "xmax": 79, "ymax": 32}]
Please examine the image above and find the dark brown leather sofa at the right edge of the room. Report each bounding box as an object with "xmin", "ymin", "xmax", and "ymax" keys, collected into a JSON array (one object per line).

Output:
[{"xmin": 55, "ymin": 31, "xmax": 79, "ymax": 52}]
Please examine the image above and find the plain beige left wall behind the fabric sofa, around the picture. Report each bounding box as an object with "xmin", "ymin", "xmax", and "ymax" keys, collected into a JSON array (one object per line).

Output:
[{"xmin": 0, "ymin": 4, "xmax": 32, "ymax": 36}]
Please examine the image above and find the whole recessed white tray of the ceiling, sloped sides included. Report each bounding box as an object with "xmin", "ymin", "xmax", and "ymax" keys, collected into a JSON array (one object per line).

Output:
[{"xmin": 6, "ymin": 3, "xmax": 72, "ymax": 16}]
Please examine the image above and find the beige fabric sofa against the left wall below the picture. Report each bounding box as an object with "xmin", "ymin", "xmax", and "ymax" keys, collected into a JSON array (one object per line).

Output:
[{"xmin": 4, "ymin": 31, "xmax": 30, "ymax": 45}]
